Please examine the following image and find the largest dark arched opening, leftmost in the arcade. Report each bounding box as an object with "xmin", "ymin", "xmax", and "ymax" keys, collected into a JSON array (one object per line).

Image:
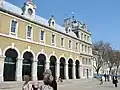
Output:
[{"xmin": 3, "ymin": 48, "xmax": 18, "ymax": 81}]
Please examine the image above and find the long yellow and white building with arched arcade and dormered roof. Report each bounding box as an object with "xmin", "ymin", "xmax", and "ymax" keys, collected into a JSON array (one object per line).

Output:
[{"xmin": 0, "ymin": 0, "xmax": 93, "ymax": 81}]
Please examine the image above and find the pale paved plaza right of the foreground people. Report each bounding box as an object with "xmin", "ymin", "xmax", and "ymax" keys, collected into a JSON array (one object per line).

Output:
[{"xmin": 59, "ymin": 80, "xmax": 120, "ymax": 90}]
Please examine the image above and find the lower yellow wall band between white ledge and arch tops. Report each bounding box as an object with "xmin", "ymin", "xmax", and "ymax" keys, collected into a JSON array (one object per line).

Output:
[{"xmin": 0, "ymin": 36, "xmax": 80, "ymax": 60}]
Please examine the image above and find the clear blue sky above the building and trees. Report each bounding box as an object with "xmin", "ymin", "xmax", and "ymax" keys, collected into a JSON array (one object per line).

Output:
[{"xmin": 7, "ymin": 0, "xmax": 120, "ymax": 49}]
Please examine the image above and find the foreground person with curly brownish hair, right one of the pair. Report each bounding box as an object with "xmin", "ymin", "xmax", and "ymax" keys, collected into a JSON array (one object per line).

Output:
[{"xmin": 39, "ymin": 69, "xmax": 53, "ymax": 90}]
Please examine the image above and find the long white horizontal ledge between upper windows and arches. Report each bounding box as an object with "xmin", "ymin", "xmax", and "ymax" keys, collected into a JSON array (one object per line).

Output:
[{"xmin": 0, "ymin": 33, "xmax": 80, "ymax": 54}]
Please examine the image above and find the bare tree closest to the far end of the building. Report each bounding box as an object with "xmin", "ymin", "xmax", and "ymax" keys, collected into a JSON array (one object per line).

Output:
[{"xmin": 93, "ymin": 41, "xmax": 105, "ymax": 74}]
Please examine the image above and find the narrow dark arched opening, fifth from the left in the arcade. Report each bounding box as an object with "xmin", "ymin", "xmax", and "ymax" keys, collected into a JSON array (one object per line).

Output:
[{"xmin": 59, "ymin": 57, "xmax": 66, "ymax": 79}]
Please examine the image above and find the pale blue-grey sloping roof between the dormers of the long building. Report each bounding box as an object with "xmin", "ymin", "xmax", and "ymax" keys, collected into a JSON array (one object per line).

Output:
[{"xmin": 2, "ymin": 1, "xmax": 77, "ymax": 38}]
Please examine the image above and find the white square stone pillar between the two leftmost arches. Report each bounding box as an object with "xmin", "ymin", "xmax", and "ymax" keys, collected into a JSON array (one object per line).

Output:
[{"xmin": 16, "ymin": 58, "xmax": 23, "ymax": 81}]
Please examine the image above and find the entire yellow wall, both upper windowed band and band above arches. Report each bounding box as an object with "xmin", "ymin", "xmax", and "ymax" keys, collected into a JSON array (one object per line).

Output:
[{"xmin": 0, "ymin": 12, "xmax": 80, "ymax": 60}]
